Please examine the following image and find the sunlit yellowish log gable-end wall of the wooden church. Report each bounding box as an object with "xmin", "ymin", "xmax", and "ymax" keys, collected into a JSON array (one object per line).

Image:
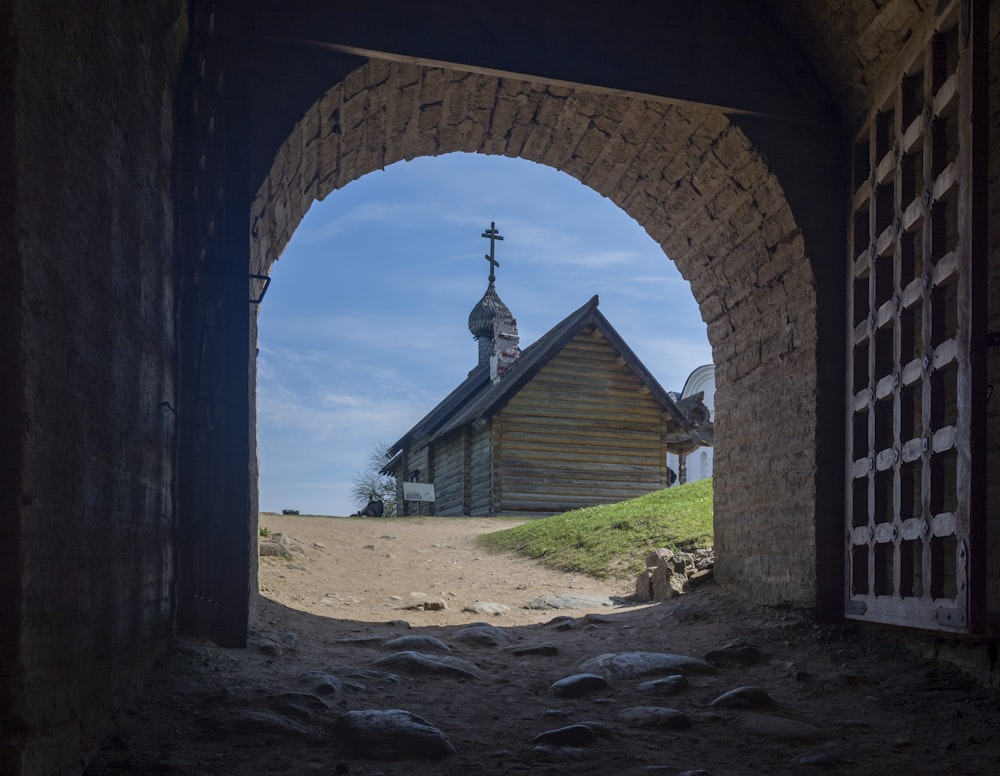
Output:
[{"xmin": 494, "ymin": 332, "xmax": 666, "ymax": 514}]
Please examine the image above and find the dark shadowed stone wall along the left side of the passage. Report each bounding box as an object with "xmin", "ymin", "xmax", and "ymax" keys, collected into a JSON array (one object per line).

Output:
[{"xmin": 0, "ymin": 0, "xmax": 187, "ymax": 776}]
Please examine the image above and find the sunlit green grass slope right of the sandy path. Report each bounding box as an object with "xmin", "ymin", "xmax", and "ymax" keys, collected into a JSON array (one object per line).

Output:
[{"xmin": 477, "ymin": 479, "xmax": 713, "ymax": 579}]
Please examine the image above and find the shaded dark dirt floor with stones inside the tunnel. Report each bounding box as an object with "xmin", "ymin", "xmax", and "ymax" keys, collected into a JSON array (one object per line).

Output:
[{"xmin": 87, "ymin": 584, "xmax": 1000, "ymax": 776}]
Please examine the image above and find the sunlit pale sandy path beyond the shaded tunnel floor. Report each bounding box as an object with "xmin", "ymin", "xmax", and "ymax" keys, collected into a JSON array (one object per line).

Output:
[{"xmin": 260, "ymin": 513, "xmax": 635, "ymax": 626}]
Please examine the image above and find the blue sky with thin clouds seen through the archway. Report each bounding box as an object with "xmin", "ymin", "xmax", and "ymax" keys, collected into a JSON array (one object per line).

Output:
[{"xmin": 257, "ymin": 154, "xmax": 712, "ymax": 515}]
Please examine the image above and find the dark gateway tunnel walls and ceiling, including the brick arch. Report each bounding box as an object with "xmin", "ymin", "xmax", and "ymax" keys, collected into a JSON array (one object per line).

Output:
[{"xmin": 0, "ymin": 0, "xmax": 1000, "ymax": 774}]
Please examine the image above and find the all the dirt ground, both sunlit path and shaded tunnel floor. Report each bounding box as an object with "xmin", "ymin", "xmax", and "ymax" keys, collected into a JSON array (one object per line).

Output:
[{"xmin": 87, "ymin": 514, "xmax": 1000, "ymax": 776}]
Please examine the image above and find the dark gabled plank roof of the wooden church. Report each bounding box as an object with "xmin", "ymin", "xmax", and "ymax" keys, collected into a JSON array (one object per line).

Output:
[{"xmin": 386, "ymin": 294, "xmax": 690, "ymax": 460}]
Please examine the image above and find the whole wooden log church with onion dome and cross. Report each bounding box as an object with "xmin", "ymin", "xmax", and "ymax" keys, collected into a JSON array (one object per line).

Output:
[{"xmin": 383, "ymin": 224, "xmax": 712, "ymax": 515}]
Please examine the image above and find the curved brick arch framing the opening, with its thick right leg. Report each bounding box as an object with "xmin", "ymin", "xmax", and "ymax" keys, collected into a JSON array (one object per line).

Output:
[{"xmin": 251, "ymin": 60, "xmax": 817, "ymax": 604}]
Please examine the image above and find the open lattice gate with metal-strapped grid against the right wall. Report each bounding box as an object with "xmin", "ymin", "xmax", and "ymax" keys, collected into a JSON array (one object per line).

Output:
[{"xmin": 845, "ymin": 0, "xmax": 987, "ymax": 632}]
